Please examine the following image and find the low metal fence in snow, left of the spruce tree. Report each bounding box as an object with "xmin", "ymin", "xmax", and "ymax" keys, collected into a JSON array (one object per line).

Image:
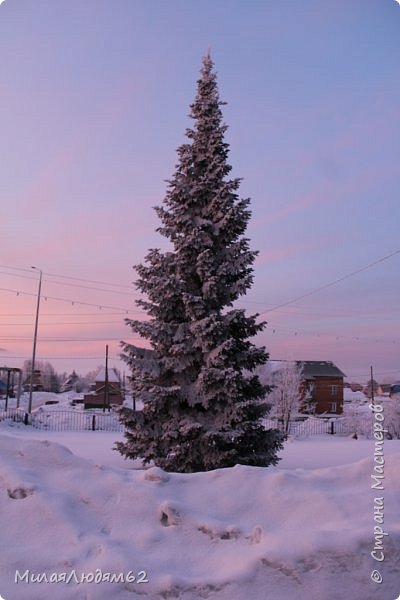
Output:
[{"xmin": 0, "ymin": 409, "xmax": 125, "ymax": 431}]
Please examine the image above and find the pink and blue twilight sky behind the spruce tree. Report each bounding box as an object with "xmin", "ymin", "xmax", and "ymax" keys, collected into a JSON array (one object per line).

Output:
[{"xmin": 0, "ymin": 0, "xmax": 400, "ymax": 381}]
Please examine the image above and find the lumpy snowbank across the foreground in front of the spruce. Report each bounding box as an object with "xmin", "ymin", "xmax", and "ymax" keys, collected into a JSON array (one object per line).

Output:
[{"xmin": 0, "ymin": 427, "xmax": 400, "ymax": 600}]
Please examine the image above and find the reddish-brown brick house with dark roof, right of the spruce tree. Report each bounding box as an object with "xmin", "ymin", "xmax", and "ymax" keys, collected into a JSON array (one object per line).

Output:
[{"xmin": 296, "ymin": 360, "xmax": 345, "ymax": 415}]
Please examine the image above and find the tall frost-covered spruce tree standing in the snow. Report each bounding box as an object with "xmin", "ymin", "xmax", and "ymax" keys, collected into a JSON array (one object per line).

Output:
[{"xmin": 116, "ymin": 55, "xmax": 284, "ymax": 472}]
